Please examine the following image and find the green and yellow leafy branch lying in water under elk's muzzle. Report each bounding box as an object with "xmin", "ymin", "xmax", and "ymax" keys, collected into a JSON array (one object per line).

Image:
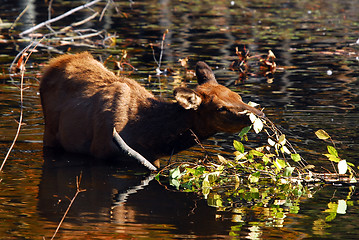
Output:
[{"xmin": 156, "ymin": 109, "xmax": 356, "ymax": 212}]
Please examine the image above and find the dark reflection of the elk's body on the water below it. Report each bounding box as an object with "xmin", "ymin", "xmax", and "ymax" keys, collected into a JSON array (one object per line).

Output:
[{"xmin": 38, "ymin": 152, "xmax": 231, "ymax": 238}]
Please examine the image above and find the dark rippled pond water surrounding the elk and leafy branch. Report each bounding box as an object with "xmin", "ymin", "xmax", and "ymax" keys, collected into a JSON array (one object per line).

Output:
[{"xmin": 0, "ymin": 0, "xmax": 359, "ymax": 239}]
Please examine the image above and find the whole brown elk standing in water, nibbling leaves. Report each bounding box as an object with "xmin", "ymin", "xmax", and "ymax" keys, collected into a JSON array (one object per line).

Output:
[{"xmin": 40, "ymin": 52, "xmax": 264, "ymax": 170}]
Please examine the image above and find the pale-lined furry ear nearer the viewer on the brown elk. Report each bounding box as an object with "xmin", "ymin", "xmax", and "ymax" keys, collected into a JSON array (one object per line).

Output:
[{"xmin": 173, "ymin": 87, "xmax": 202, "ymax": 110}]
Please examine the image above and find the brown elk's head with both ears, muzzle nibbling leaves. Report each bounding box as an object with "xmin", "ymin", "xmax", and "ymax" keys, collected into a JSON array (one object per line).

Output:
[{"xmin": 174, "ymin": 62, "xmax": 264, "ymax": 133}]
